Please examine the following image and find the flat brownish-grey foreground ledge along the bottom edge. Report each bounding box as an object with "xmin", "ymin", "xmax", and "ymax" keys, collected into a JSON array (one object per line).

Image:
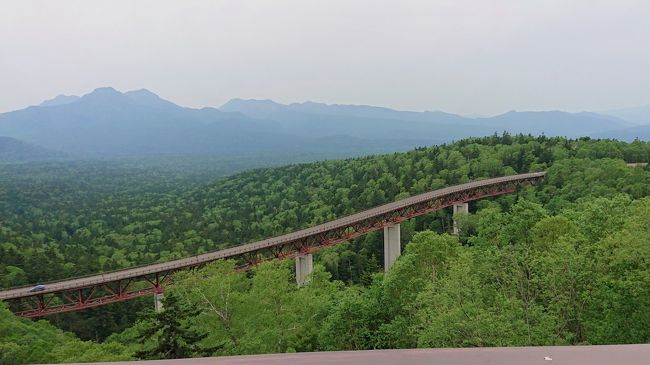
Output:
[{"xmin": 67, "ymin": 345, "xmax": 650, "ymax": 365}]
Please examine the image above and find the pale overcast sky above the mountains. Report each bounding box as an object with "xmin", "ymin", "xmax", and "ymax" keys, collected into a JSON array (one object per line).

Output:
[{"xmin": 0, "ymin": 0, "xmax": 650, "ymax": 115}]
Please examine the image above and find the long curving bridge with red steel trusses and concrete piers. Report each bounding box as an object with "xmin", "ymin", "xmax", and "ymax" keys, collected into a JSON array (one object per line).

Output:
[{"xmin": 0, "ymin": 172, "xmax": 545, "ymax": 318}]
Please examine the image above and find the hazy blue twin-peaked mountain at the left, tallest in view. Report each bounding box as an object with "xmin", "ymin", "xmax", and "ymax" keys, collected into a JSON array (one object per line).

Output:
[{"xmin": 0, "ymin": 88, "xmax": 294, "ymax": 155}]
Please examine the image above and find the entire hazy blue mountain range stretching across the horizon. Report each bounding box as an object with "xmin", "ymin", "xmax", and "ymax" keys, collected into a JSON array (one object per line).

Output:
[{"xmin": 0, "ymin": 88, "xmax": 650, "ymax": 157}]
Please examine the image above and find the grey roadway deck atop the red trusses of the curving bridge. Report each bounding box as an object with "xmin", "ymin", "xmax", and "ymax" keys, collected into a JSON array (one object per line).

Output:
[{"xmin": 0, "ymin": 172, "xmax": 545, "ymax": 300}]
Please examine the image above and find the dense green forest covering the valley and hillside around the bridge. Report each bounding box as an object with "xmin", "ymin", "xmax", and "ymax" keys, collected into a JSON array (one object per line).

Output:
[{"xmin": 0, "ymin": 134, "xmax": 650, "ymax": 364}]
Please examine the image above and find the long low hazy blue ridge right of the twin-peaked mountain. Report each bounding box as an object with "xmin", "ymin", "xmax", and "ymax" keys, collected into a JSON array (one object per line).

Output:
[{"xmin": 220, "ymin": 99, "xmax": 631, "ymax": 141}]
